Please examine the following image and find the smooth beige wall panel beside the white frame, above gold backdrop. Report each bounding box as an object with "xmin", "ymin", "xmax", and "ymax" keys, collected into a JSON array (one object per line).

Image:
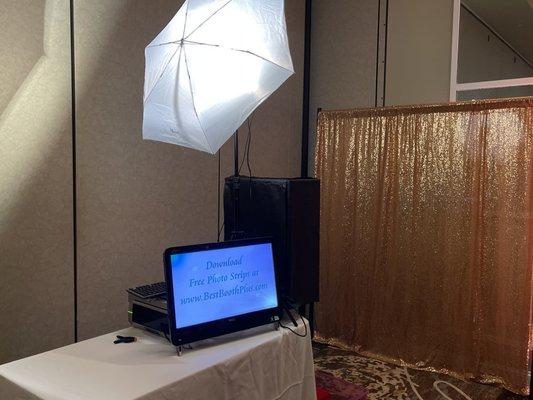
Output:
[{"xmin": 385, "ymin": 0, "xmax": 453, "ymax": 105}]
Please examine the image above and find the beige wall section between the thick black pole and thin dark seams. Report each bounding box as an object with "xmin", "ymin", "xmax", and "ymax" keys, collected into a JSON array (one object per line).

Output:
[{"xmin": 309, "ymin": 0, "xmax": 379, "ymax": 168}]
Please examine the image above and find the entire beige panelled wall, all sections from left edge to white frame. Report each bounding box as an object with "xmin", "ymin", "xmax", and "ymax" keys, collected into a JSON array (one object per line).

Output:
[{"xmin": 0, "ymin": 0, "xmax": 462, "ymax": 361}]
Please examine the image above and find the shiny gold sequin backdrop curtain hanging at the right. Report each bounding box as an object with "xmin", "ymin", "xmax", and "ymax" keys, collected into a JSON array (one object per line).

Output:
[{"xmin": 315, "ymin": 99, "xmax": 533, "ymax": 393}]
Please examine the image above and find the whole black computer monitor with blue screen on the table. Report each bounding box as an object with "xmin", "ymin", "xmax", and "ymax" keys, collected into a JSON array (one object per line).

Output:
[{"xmin": 164, "ymin": 239, "xmax": 280, "ymax": 346}]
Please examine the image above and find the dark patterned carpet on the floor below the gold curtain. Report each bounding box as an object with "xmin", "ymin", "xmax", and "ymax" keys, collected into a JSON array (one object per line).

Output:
[{"xmin": 313, "ymin": 342, "xmax": 527, "ymax": 400}]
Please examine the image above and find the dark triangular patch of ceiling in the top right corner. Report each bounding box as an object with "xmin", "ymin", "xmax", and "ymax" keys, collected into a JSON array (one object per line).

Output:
[{"xmin": 462, "ymin": 0, "xmax": 533, "ymax": 64}]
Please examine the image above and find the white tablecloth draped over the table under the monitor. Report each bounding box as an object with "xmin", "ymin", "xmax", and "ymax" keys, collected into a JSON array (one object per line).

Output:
[{"xmin": 0, "ymin": 322, "xmax": 316, "ymax": 400}]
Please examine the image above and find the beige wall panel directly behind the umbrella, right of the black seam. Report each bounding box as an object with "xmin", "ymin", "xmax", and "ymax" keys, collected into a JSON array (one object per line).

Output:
[{"xmin": 75, "ymin": 0, "xmax": 304, "ymax": 339}]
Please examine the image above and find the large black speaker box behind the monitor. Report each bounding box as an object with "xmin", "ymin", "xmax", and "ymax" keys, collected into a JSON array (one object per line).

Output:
[{"xmin": 224, "ymin": 176, "xmax": 320, "ymax": 305}]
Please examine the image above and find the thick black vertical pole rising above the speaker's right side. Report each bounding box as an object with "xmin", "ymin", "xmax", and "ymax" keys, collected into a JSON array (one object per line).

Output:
[{"xmin": 301, "ymin": 0, "xmax": 312, "ymax": 178}]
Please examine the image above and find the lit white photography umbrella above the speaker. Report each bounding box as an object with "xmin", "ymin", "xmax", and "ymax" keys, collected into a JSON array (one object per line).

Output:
[{"xmin": 143, "ymin": 0, "xmax": 294, "ymax": 154}]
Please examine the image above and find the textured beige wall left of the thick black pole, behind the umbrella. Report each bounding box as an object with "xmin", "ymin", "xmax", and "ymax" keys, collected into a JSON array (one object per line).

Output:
[{"xmin": 0, "ymin": 0, "xmax": 305, "ymax": 363}]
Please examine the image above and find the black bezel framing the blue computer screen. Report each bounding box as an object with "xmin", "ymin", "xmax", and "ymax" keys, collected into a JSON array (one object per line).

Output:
[{"xmin": 164, "ymin": 237, "xmax": 281, "ymax": 346}]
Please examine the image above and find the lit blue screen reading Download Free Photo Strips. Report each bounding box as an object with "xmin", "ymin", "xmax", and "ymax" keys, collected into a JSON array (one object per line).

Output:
[{"xmin": 170, "ymin": 243, "xmax": 278, "ymax": 329}]
